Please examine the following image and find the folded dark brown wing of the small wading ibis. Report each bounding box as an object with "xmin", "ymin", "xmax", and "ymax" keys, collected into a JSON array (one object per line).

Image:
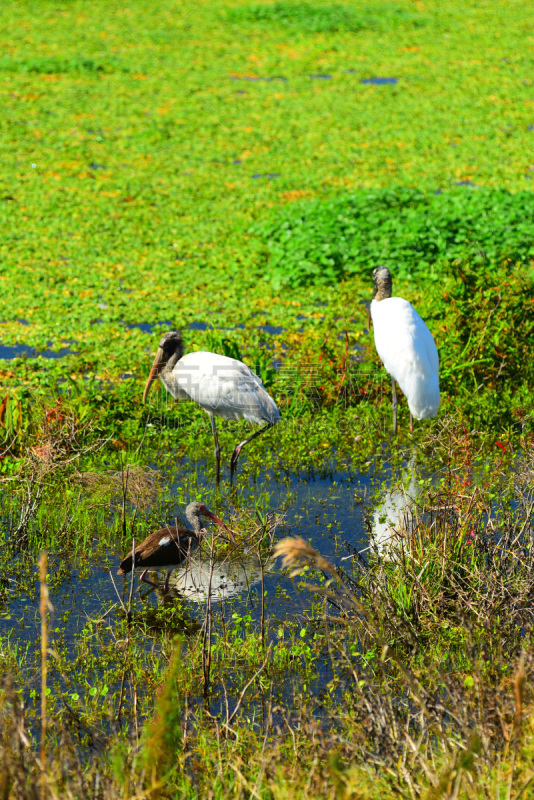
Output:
[{"xmin": 118, "ymin": 525, "xmax": 198, "ymax": 575}]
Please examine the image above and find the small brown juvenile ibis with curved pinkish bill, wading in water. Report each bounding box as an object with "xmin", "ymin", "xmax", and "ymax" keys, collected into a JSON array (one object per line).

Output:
[{"xmin": 117, "ymin": 501, "xmax": 235, "ymax": 592}]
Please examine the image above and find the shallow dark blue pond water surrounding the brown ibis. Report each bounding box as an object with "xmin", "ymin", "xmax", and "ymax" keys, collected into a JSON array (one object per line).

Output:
[{"xmin": 0, "ymin": 455, "xmax": 432, "ymax": 744}]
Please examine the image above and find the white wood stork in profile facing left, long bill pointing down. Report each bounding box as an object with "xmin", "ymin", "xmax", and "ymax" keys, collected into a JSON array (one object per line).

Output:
[{"xmin": 143, "ymin": 331, "xmax": 280, "ymax": 484}]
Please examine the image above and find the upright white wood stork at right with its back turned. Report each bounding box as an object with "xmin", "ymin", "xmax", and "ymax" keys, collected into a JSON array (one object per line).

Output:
[{"xmin": 371, "ymin": 267, "xmax": 440, "ymax": 433}]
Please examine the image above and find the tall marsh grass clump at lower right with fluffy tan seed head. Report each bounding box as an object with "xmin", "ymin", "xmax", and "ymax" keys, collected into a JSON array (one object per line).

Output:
[{"xmin": 275, "ymin": 429, "xmax": 534, "ymax": 798}]
